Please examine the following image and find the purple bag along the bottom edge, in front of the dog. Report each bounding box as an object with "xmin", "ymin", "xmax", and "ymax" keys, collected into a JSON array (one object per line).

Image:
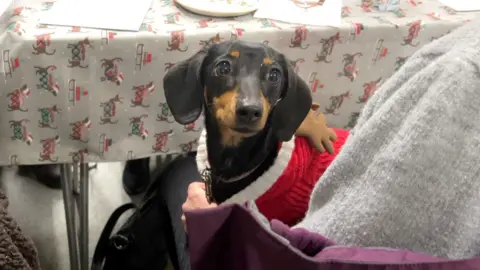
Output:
[{"xmin": 185, "ymin": 205, "xmax": 480, "ymax": 270}]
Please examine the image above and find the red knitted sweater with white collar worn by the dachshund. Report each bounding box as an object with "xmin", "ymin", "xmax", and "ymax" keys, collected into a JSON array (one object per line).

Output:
[{"xmin": 197, "ymin": 129, "xmax": 349, "ymax": 225}]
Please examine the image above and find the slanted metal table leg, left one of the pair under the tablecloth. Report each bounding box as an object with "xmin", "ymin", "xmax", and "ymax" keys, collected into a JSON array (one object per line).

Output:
[{"xmin": 60, "ymin": 164, "xmax": 80, "ymax": 270}]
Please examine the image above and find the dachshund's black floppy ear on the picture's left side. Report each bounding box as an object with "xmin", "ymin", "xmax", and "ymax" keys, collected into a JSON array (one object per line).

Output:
[{"xmin": 163, "ymin": 48, "xmax": 207, "ymax": 125}]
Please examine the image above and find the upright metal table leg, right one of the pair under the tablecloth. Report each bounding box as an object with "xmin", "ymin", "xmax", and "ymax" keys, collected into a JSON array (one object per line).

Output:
[{"xmin": 79, "ymin": 163, "xmax": 89, "ymax": 270}]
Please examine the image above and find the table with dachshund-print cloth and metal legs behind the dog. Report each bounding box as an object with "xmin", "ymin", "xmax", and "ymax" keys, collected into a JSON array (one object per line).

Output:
[{"xmin": 0, "ymin": 0, "xmax": 478, "ymax": 269}]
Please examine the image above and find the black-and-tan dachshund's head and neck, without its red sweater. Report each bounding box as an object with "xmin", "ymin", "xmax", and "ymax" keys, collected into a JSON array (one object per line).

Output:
[{"xmin": 163, "ymin": 41, "xmax": 344, "ymax": 226}]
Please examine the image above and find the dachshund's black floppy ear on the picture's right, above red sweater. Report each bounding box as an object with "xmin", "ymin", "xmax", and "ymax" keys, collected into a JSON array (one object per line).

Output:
[{"xmin": 271, "ymin": 56, "xmax": 312, "ymax": 141}]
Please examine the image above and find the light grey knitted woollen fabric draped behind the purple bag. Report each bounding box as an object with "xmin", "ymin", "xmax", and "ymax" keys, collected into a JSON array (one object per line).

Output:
[{"xmin": 297, "ymin": 20, "xmax": 480, "ymax": 258}]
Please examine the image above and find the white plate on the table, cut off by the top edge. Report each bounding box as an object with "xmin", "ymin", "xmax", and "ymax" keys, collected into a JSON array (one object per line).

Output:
[{"xmin": 175, "ymin": 0, "xmax": 258, "ymax": 17}]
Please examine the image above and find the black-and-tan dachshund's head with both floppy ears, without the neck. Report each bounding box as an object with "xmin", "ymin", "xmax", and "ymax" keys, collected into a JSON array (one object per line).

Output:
[{"xmin": 163, "ymin": 41, "xmax": 312, "ymax": 146}]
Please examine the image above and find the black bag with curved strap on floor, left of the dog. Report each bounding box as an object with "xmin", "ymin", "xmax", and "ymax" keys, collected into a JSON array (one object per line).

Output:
[{"xmin": 91, "ymin": 174, "xmax": 168, "ymax": 270}]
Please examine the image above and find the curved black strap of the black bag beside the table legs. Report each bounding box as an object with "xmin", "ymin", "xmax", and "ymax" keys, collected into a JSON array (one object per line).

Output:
[{"xmin": 91, "ymin": 203, "xmax": 137, "ymax": 270}]
